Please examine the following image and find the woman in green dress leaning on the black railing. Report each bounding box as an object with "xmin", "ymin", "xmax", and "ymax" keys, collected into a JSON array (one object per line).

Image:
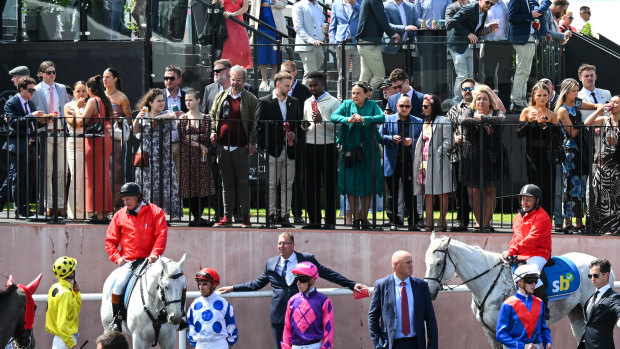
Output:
[{"xmin": 331, "ymin": 82, "xmax": 385, "ymax": 229}]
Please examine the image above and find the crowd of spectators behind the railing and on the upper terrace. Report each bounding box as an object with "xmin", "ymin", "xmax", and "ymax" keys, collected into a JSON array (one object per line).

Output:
[{"xmin": 0, "ymin": 0, "xmax": 618, "ymax": 233}]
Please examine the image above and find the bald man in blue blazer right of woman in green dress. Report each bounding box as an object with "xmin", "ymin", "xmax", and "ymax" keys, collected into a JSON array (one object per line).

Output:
[{"xmin": 379, "ymin": 96, "xmax": 422, "ymax": 231}]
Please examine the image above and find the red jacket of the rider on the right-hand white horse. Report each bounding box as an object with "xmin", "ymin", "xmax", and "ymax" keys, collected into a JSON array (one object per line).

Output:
[{"xmin": 508, "ymin": 207, "xmax": 551, "ymax": 260}]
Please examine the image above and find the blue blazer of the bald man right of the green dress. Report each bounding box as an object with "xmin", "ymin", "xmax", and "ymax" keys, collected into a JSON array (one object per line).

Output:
[{"xmin": 379, "ymin": 114, "xmax": 423, "ymax": 177}]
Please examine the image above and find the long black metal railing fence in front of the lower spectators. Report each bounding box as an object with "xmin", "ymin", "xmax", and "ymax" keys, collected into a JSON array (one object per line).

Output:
[{"xmin": 0, "ymin": 116, "xmax": 620, "ymax": 233}]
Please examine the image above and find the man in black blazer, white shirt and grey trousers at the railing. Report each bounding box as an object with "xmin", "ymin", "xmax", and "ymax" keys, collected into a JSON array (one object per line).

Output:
[{"xmin": 255, "ymin": 72, "xmax": 303, "ymax": 228}]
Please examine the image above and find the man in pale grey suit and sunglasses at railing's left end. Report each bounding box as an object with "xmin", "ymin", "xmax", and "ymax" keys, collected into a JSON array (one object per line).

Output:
[{"xmin": 32, "ymin": 61, "xmax": 68, "ymax": 216}]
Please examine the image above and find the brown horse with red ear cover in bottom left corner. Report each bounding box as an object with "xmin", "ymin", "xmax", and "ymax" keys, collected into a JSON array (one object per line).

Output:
[{"xmin": 0, "ymin": 274, "xmax": 42, "ymax": 348}]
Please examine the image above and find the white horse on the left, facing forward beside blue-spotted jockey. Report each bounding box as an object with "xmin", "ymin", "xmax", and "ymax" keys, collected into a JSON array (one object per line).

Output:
[{"xmin": 101, "ymin": 255, "xmax": 186, "ymax": 349}]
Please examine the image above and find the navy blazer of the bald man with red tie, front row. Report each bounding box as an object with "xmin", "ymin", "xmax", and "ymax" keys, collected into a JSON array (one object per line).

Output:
[{"xmin": 368, "ymin": 274, "xmax": 439, "ymax": 349}]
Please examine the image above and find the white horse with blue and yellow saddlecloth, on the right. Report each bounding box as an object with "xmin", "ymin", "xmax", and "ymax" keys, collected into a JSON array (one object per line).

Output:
[{"xmin": 424, "ymin": 233, "xmax": 613, "ymax": 349}]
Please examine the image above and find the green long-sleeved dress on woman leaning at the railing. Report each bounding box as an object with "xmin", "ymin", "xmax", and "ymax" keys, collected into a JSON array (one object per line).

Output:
[{"xmin": 331, "ymin": 100, "xmax": 385, "ymax": 196}]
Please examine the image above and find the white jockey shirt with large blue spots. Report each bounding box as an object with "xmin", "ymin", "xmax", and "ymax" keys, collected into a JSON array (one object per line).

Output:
[{"xmin": 187, "ymin": 293, "xmax": 239, "ymax": 347}]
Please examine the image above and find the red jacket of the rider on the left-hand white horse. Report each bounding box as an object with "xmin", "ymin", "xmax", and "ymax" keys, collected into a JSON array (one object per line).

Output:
[{"xmin": 105, "ymin": 204, "xmax": 168, "ymax": 263}]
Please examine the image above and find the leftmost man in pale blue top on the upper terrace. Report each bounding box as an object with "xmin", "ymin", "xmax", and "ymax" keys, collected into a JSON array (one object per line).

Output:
[{"xmin": 293, "ymin": 0, "xmax": 327, "ymax": 84}]
